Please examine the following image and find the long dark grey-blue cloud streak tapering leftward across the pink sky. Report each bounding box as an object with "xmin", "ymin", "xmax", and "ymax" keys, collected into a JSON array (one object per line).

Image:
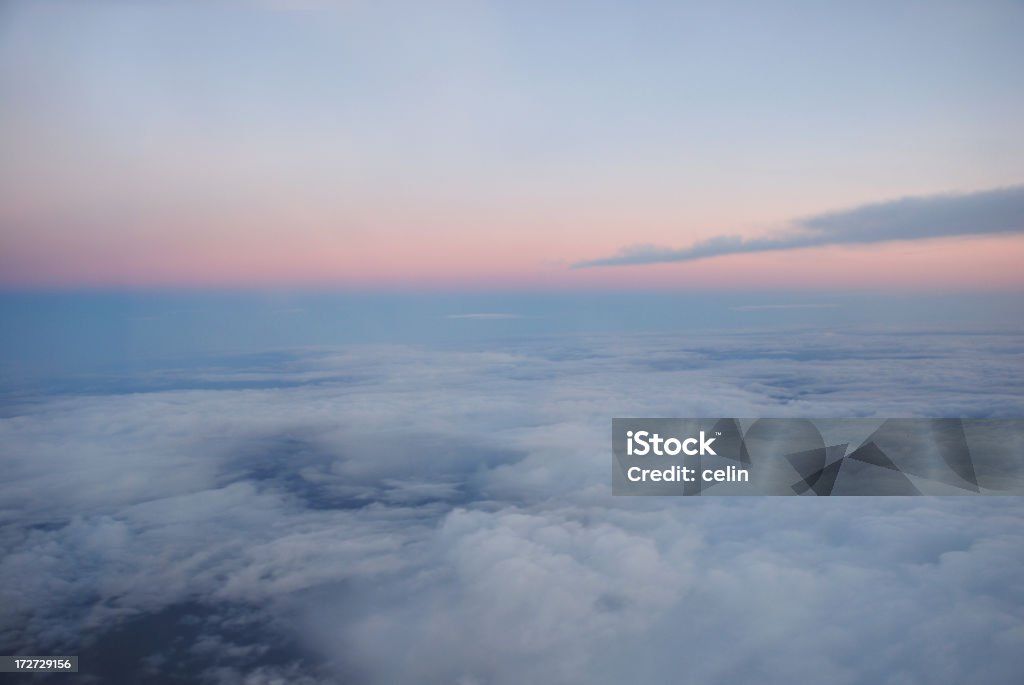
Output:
[{"xmin": 572, "ymin": 185, "xmax": 1024, "ymax": 268}]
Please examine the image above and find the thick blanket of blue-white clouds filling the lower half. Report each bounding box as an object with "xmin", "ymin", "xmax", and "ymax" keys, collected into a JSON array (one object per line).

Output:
[{"xmin": 0, "ymin": 332, "xmax": 1024, "ymax": 685}]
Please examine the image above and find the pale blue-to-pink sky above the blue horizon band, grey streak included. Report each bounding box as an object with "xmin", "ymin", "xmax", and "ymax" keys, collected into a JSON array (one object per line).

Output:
[{"xmin": 0, "ymin": 0, "xmax": 1024, "ymax": 293}]
